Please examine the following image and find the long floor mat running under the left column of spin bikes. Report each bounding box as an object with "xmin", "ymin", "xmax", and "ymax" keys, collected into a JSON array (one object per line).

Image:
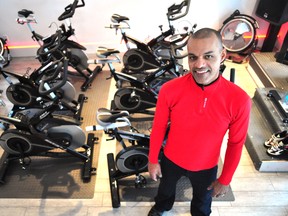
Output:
[{"xmin": 0, "ymin": 58, "xmax": 110, "ymax": 199}]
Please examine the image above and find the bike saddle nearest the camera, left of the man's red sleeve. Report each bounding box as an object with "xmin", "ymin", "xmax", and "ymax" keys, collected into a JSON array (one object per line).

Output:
[{"xmin": 96, "ymin": 108, "xmax": 129, "ymax": 126}]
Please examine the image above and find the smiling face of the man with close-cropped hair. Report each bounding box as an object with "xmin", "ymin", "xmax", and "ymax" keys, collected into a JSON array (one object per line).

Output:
[{"xmin": 187, "ymin": 35, "xmax": 226, "ymax": 85}]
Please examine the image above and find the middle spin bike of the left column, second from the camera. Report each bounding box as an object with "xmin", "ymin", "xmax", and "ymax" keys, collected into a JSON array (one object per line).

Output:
[{"xmin": 0, "ymin": 31, "xmax": 87, "ymax": 120}]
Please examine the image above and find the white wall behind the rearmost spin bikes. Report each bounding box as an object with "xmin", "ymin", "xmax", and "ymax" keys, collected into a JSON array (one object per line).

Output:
[{"xmin": 0, "ymin": 0, "xmax": 260, "ymax": 56}]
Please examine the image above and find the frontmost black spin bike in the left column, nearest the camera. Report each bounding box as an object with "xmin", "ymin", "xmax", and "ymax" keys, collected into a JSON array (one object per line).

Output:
[{"xmin": 0, "ymin": 59, "xmax": 96, "ymax": 183}]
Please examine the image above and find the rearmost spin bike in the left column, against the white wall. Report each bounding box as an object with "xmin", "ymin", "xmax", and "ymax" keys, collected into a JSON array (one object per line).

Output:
[{"xmin": 17, "ymin": 0, "xmax": 101, "ymax": 91}]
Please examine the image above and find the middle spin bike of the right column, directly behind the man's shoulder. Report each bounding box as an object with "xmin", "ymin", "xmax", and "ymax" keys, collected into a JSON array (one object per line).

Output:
[{"xmin": 89, "ymin": 33, "xmax": 189, "ymax": 116}]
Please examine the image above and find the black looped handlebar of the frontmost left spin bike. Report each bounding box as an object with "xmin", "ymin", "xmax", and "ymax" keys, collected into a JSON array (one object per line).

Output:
[{"xmin": 38, "ymin": 58, "xmax": 68, "ymax": 95}]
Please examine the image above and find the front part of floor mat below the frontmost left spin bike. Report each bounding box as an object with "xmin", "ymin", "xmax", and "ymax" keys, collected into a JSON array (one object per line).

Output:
[{"xmin": 0, "ymin": 149, "xmax": 96, "ymax": 199}]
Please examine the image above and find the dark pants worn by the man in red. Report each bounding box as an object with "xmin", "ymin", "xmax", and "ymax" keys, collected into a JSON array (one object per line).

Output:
[{"xmin": 155, "ymin": 156, "xmax": 218, "ymax": 216}]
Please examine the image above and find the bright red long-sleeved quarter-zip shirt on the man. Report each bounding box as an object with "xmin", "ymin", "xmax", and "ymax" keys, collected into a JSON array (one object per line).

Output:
[{"xmin": 149, "ymin": 73, "xmax": 251, "ymax": 185}]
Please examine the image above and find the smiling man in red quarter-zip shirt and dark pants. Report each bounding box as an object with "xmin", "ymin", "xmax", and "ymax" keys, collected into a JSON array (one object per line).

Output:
[{"xmin": 148, "ymin": 28, "xmax": 251, "ymax": 216}]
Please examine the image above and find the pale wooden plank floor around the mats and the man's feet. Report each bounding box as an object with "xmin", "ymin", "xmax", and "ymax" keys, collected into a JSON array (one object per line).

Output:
[{"xmin": 0, "ymin": 58, "xmax": 288, "ymax": 216}]
